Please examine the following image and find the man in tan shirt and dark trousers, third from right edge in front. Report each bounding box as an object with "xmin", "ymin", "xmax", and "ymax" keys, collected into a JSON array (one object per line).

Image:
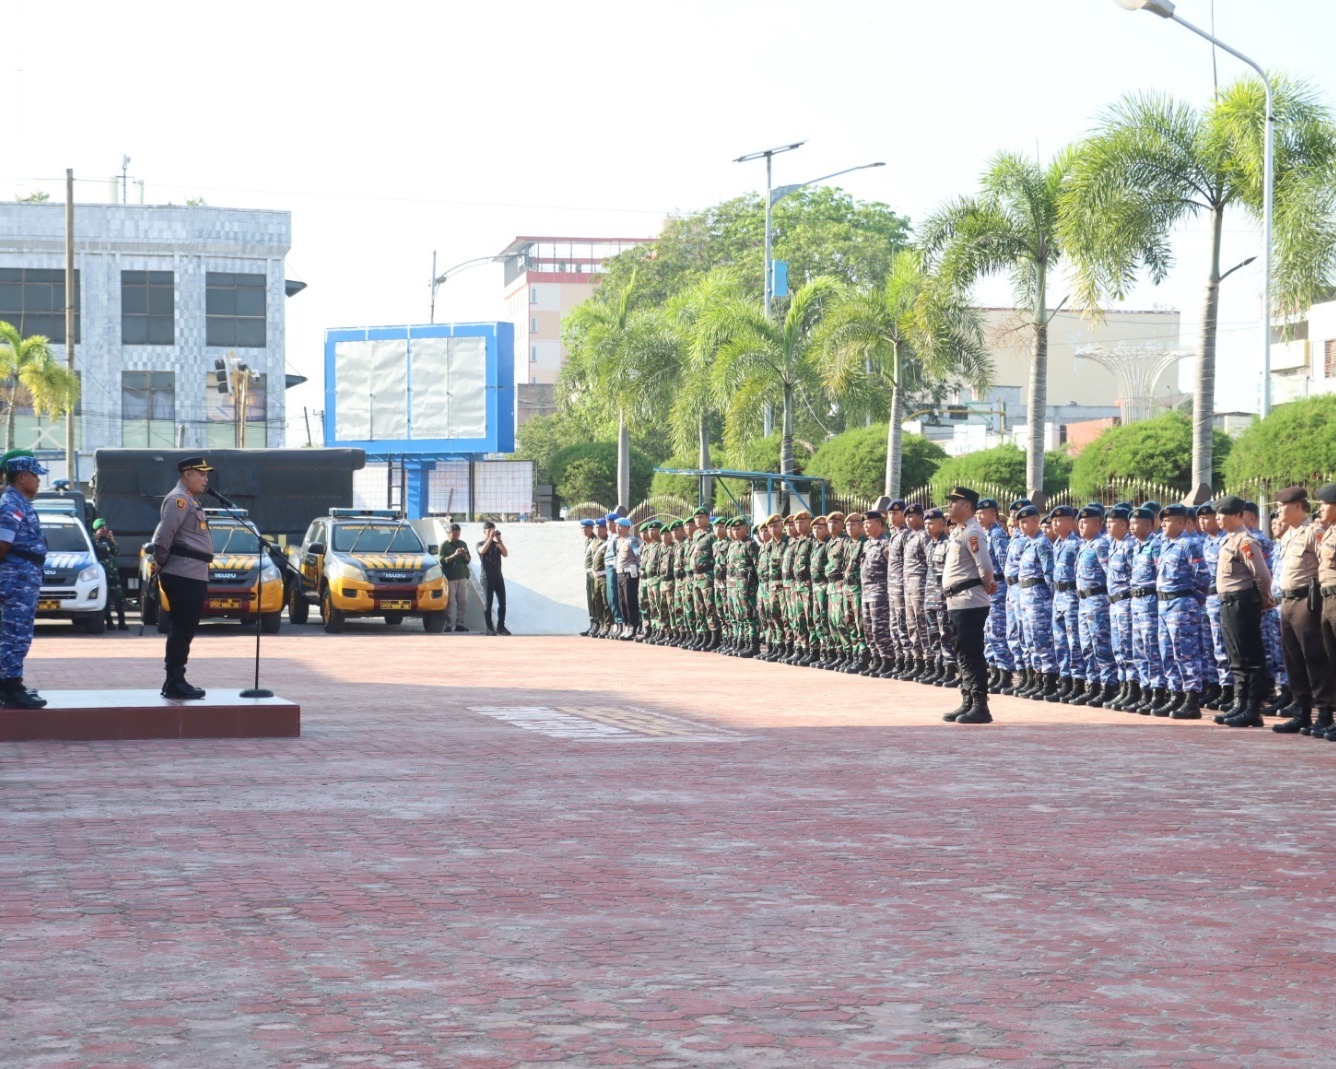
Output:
[{"xmin": 1214, "ymin": 496, "xmax": 1277, "ymax": 734}]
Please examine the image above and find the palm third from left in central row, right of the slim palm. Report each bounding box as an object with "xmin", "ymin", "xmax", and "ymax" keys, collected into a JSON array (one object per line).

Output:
[{"xmin": 705, "ymin": 275, "xmax": 840, "ymax": 474}]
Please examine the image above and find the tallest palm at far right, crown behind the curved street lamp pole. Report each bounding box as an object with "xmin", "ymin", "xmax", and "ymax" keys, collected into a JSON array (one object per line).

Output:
[{"xmin": 1061, "ymin": 79, "xmax": 1336, "ymax": 500}]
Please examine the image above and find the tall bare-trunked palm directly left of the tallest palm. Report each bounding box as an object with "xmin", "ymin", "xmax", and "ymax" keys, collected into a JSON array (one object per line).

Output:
[{"xmin": 921, "ymin": 150, "xmax": 1070, "ymax": 498}]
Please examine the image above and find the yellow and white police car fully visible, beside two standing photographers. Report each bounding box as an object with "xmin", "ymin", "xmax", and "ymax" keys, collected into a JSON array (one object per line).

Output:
[{"xmin": 287, "ymin": 509, "xmax": 446, "ymax": 633}]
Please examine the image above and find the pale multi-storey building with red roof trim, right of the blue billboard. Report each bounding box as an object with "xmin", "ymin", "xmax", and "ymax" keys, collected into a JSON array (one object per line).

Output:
[{"xmin": 496, "ymin": 237, "xmax": 653, "ymax": 426}]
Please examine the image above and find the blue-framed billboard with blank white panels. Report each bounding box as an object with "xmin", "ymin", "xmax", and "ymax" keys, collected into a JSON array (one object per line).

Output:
[{"xmin": 325, "ymin": 322, "xmax": 514, "ymax": 460}]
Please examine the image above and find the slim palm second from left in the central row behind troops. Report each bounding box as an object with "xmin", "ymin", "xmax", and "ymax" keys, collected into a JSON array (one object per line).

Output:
[{"xmin": 668, "ymin": 269, "xmax": 744, "ymax": 504}]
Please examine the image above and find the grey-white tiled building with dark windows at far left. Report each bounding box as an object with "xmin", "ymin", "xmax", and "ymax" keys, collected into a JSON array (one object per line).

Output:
[{"xmin": 0, "ymin": 202, "xmax": 302, "ymax": 478}]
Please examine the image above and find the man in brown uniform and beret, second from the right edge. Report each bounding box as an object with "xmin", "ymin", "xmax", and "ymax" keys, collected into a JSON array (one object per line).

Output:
[{"xmin": 1276, "ymin": 486, "xmax": 1336, "ymax": 732}]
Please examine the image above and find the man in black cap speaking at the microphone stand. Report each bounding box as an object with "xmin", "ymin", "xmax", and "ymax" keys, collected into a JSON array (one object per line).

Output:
[{"xmin": 150, "ymin": 457, "xmax": 214, "ymax": 699}]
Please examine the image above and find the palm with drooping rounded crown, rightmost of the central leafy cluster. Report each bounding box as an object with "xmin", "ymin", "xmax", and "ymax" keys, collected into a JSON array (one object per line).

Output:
[{"xmin": 820, "ymin": 249, "xmax": 993, "ymax": 497}]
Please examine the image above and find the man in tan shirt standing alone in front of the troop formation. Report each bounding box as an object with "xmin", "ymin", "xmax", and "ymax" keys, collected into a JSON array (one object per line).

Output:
[{"xmin": 942, "ymin": 486, "xmax": 998, "ymax": 724}]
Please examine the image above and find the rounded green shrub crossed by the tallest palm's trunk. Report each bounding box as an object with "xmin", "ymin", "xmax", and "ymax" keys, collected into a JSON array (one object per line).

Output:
[{"xmin": 1068, "ymin": 412, "xmax": 1233, "ymax": 498}]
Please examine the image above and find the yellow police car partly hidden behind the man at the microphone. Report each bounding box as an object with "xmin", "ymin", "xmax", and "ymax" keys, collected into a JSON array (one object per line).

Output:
[{"xmin": 139, "ymin": 509, "xmax": 283, "ymax": 635}]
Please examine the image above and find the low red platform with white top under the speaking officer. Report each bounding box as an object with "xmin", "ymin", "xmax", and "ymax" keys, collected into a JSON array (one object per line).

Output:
[{"xmin": 0, "ymin": 690, "xmax": 302, "ymax": 743}]
